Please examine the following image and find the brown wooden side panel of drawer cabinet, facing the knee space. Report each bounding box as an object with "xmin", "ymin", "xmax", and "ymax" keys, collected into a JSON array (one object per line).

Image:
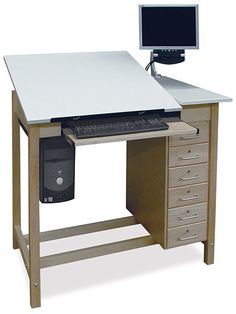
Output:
[{"xmin": 126, "ymin": 137, "xmax": 168, "ymax": 248}]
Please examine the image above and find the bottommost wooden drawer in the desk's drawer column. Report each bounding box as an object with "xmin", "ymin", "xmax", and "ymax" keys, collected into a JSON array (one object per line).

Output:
[{"xmin": 168, "ymin": 222, "xmax": 207, "ymax": 248}]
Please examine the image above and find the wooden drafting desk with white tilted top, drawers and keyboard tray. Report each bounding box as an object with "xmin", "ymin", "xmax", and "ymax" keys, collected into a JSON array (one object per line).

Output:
[{"xmin": 5, "ymin": 52, "xmax": 231, "ymax": 307}]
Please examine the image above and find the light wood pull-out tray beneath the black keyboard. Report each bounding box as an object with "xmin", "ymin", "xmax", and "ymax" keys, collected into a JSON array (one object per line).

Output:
[{"xmin": 62, "ymin": 121, "xmax": 197, "ymax": 146}]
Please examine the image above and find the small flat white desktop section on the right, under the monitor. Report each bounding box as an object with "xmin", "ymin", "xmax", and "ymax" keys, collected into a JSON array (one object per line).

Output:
[{"xmin": 156, "ymin": 76, "xmax": 232, "ymax": 105}]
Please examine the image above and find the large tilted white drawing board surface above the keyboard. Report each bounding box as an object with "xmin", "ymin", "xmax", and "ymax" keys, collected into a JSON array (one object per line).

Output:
[{"xmin": 5, "ymin": 51, "xmax": 181, "ymax": 124}]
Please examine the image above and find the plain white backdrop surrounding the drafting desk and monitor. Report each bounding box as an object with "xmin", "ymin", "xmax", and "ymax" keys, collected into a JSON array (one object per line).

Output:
[{"xmin": 0, "ymin": 0, "xmax": 236, "ymax": 313}]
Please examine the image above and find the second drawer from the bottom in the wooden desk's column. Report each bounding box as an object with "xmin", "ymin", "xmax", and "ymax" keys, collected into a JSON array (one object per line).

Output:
[{"xmin": 168, "ymin": 202, "xmax": 207, "ymax": 228}]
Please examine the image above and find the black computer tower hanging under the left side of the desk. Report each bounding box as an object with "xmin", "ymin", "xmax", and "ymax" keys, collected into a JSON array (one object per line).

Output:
[{"xmin": 39, "ymin": 136, "xmax": 75, "ymax": 203}]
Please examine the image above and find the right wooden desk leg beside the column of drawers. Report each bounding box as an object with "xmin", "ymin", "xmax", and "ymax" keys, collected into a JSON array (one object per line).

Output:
[{"xmin": 204, "ymin": 104, "xmax": 219, "ymax": 265}]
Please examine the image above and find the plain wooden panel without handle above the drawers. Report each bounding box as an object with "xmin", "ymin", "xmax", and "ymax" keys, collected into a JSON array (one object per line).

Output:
[{"xmin": 181, "ymin": 105, "xmax": 210, "ymax": 122}]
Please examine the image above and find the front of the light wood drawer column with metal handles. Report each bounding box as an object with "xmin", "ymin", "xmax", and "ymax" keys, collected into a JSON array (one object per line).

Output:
[{"xmin": 166, "ymin": 105, "xmax": 210, "ymax": 248}]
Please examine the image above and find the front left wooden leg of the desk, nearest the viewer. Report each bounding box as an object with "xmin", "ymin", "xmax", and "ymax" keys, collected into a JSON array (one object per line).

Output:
[{"xmin": 28, "ymin": 126, "xmax": 41, "ymax": 308}]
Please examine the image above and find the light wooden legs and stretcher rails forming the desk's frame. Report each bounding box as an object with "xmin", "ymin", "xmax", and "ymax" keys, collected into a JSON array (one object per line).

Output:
[{"xmin": 12, "ymin": 91, "xmax": 218, "ymax": 308}]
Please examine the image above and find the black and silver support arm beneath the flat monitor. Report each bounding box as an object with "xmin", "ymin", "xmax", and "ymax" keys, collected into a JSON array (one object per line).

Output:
[{"xmin": 150, "ymin": 49, "xmax": 185, "ymax": 77}]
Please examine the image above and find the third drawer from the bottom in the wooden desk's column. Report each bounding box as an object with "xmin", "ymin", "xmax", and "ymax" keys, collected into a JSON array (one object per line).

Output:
[{"xmin": 168, "ymin": 183, "xmax": 208, "ymax": 208}]
